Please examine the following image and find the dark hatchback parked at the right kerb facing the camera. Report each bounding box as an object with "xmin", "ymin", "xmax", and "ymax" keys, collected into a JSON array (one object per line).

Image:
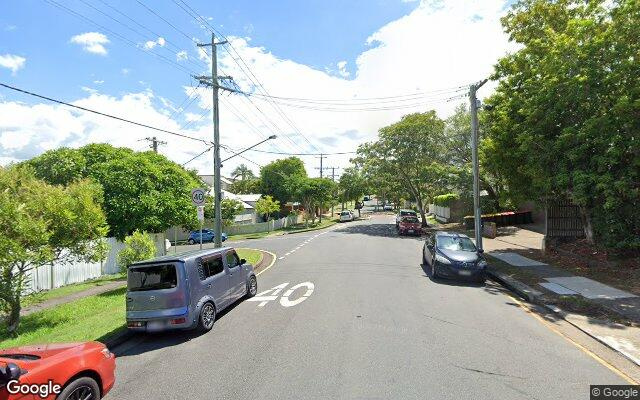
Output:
[{"xmin": 422, "ymin": 231, "xmax": 487, "ymax": 282}]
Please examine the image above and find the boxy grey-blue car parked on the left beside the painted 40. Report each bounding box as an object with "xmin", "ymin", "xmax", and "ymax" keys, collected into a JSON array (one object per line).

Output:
[{"xmin": 127, "ymin": 247, "xmax": 258, "ymax": 332}]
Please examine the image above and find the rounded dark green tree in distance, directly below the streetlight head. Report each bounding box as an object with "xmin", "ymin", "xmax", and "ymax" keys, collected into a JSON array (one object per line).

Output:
[{"xmin": 260, "ymin": 157, "xmax": 307, "ymax": 204}]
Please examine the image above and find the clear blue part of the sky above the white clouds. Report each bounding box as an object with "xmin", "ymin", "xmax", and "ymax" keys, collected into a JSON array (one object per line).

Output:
[{"xmin": 0, "ymin": 0, "xmax": 418, "ymax": 108}]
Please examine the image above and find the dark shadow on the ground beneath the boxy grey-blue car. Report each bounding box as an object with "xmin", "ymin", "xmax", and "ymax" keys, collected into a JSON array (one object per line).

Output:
[{"xmin": 114, "ymin": 299, "xmax": 244, "ymax": 357}]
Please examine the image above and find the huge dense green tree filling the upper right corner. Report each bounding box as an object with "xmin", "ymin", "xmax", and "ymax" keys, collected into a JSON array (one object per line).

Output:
[{"xmin": 482, "ymin": 0, "xmax": 640, "ymax": 249}]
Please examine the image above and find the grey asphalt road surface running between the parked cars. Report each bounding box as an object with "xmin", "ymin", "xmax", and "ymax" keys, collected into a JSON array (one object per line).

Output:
[{"xmin": 107, "ymin": 215, "xmax": 627, "ymax": 400}]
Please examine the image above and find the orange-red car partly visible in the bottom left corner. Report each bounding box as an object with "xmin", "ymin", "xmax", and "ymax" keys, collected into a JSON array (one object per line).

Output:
[{"xmin": 0, "ymin": 342, "xmax": 116, "ymax": 400}]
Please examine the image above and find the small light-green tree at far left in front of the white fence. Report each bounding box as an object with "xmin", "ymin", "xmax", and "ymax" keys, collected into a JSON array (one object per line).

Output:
[{"xmin": 0, "ymin": 165, "xmax": 107, "ymax": 335}]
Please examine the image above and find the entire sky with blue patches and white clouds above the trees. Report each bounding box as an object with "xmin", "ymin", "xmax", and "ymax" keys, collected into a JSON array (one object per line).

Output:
[{"xmin": 0, "ymin": 0, "xmax": 514, "ymax": 176}]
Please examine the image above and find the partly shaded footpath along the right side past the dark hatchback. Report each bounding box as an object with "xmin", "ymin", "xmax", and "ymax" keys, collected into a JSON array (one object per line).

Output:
[{"xmin": 482, "ymin": 227, "xmax": 640, "ymax": 366}]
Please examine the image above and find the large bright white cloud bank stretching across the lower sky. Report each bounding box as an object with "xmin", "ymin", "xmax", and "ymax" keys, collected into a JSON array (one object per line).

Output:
[{"xmin": 0, "ymin": 0, "xmax": 513, "ymax": 175}]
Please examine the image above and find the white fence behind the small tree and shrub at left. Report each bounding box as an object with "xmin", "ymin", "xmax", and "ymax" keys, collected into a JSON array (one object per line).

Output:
[{"xmin": 25, "ymin": 234, "xmax": 166, "ymax": 293}]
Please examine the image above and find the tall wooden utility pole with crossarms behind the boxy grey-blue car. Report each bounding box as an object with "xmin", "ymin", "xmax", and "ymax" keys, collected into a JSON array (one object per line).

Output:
[{"xmin": 195, "ymin": 33, "xmax": 237, "ymax": 247}]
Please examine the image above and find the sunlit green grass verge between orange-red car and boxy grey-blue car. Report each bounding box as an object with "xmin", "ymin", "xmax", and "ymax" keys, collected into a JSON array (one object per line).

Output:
[{"xmin": 0, "ymin": 288, "xmax": 126, "ymax": 348}]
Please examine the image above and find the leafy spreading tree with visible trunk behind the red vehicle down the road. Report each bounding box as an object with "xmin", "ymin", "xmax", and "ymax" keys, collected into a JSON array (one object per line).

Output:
[{"xmin": 355, "ymin": 111, "xmax": 450, "ymax": 226}]
